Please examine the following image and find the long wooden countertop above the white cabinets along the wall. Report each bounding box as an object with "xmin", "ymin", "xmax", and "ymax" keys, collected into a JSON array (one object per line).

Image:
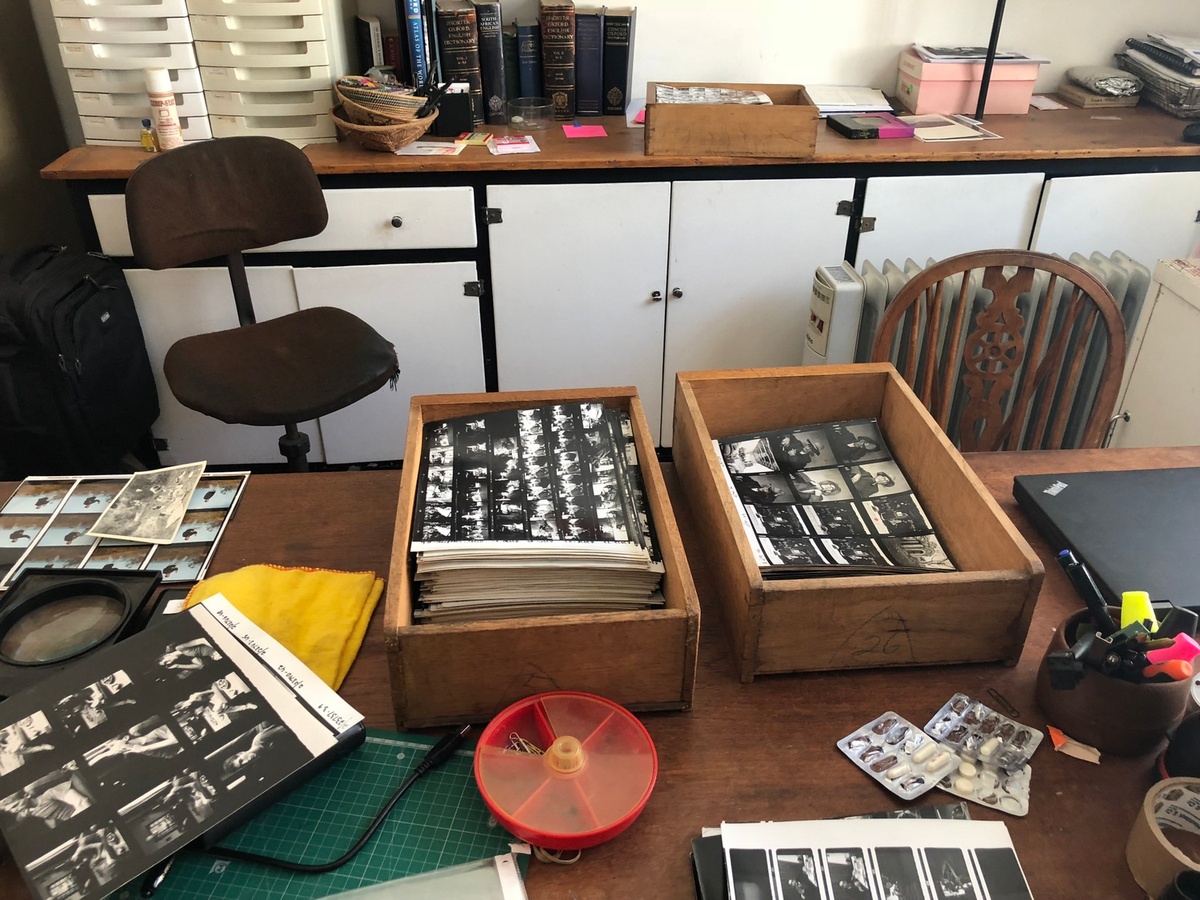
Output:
[{"xmin": 42, "ymin": 107, "xmax": 1200, "ymax": 180}]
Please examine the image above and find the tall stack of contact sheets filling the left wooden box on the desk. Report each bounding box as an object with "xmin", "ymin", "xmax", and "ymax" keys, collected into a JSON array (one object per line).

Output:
[{"xmin": 410, "ymin": 402, "xmax": 664, "ymax": 620}]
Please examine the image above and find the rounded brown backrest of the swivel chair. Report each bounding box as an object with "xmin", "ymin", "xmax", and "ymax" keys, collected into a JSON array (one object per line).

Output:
[{"xmin": 125, "ymin": 136, "xmax": 329, "ymax": 269}]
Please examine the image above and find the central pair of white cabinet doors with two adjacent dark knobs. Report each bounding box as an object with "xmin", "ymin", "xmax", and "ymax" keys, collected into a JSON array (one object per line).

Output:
[{"xmin": 488, "ymin": 179, "xmax": 853, "ymax": 446}]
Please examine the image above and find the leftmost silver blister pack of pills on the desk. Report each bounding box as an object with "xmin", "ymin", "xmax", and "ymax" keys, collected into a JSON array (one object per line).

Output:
[{"xmin": 838, "ymin": 712, "xmax": 961, "ymax": 800}]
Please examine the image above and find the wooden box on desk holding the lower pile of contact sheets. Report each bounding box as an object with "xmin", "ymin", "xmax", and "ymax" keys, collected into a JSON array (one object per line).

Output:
[{"xmin": 673, "ymin": 362, "xmax": 1044, "ymax": 682}]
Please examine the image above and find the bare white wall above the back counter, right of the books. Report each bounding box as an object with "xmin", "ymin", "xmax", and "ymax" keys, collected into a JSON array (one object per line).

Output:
[{"xmin": 503, "ymin": 0, "xmax": 1185, "ymax": 97}]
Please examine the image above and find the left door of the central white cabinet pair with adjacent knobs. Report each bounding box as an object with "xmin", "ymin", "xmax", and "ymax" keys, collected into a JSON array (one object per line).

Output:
[{"xmin": 487, "ymin": 181, "xmax": 671, "ymax": 442}]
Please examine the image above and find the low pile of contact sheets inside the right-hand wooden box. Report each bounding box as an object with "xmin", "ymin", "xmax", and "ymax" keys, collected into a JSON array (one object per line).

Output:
[{"xmin": 714, "ymin": 419, "xmax": 954, "ymax": 578}]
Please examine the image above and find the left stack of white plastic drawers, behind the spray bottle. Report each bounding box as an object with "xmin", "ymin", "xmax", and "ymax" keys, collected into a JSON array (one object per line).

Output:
[{"xmin": 50, "ymin": 0, "xmax": 212, "ymax": 146}]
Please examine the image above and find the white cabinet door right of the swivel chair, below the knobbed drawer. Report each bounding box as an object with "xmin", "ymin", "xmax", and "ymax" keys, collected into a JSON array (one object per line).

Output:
[{"xmin": 294, "ymin": 262, "xmax": 485, "ymax": 463}]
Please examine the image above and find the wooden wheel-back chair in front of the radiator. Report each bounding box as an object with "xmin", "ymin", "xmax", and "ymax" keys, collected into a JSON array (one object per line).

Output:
[{"xmin": 871, "ymin": 250, "xmax": 1126, "ymax": 451}]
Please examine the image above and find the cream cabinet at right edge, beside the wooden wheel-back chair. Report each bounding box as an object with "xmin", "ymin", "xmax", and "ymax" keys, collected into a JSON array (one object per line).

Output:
[{"xmin": 1111, "ymin": 259, "xmax": 1200, "ymax": 446}]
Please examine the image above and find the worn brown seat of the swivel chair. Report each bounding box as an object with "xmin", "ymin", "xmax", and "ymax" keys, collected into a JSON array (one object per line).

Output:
[{"xmin": 163, "ymin": 306, "xmax": 396, "ymax": 425}]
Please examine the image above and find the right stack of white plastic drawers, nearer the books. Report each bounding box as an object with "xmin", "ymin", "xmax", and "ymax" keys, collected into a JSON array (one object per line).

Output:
[{"xmin": 187, "ymin": 0, "xmax": 348, "ymax": 144}]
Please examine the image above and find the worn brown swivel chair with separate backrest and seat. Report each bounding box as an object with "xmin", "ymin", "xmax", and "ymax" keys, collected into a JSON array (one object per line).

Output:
[{"xmin": 125, "ymin": 137, "xmax": 400, "ymax": 472}]
